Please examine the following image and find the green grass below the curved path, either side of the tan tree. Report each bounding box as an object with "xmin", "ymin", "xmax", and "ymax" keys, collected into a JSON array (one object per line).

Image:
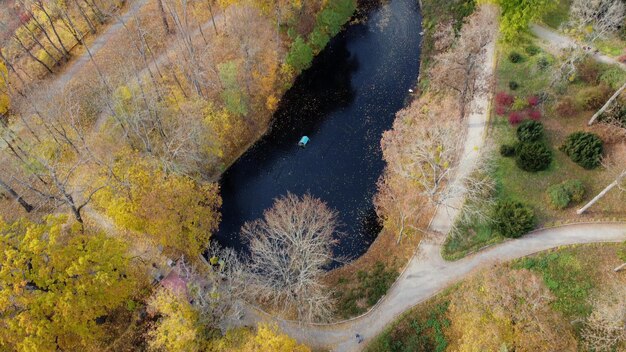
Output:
[{"xmin": 365, "ymin": 243, "xmax": 626, "ymax": 352}]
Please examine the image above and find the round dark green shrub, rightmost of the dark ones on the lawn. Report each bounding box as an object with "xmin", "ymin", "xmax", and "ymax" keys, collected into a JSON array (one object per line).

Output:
[{"xmin": 561, "ymin": 132, "xmax": 604, "ymax": 169}]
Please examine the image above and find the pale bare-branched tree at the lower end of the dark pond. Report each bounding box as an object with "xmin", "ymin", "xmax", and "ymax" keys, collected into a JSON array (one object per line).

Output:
[{"xmin": 241, "ymin": 193, "xmax": 337, "ymax": 322}]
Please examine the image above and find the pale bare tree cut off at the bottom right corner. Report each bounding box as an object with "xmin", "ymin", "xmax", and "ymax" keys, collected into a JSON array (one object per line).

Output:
[{"xmin": 581, "ymin": 285, "xmax": 626, "ymax": 352}]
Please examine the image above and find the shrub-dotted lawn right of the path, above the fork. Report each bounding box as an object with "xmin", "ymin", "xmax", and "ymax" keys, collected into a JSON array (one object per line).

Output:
[{"xmin": 442, "ymin": 37, "xmax": 626, "ymax": 260}]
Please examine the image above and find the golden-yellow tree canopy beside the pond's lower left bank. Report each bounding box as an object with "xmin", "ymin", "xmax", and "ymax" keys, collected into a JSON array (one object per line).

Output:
[{"xmin": 94, "ymin": 152, "xmax": 222, "ymax": 258}]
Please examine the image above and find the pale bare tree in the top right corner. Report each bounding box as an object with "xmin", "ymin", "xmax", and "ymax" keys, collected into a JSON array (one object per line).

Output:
[{"xmin": 570, "ymin": 0, "xmax": 626, "ymax": 42}]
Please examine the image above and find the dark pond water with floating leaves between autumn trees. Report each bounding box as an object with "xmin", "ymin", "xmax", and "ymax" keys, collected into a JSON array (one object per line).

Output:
[{"xmin": 215, "ymin": 0, "xmax": 421, "ymax": 264}]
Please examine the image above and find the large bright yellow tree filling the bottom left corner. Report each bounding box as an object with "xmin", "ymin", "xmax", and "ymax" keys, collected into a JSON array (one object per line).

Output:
[{"xmin": 0, "ymin": 216, "xmax": 138, "ymax": 351}]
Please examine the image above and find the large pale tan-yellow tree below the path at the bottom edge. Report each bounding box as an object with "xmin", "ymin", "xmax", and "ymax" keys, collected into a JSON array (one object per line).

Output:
[{"xmin": 446, "ymin": 266, "xmax": 576, "ymax": 352}]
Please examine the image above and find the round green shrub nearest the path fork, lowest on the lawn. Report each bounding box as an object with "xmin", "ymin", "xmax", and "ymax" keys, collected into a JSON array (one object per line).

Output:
[{"xmin": 494, "ymin": 201, "xmax": 535, "ymax": 238}]
